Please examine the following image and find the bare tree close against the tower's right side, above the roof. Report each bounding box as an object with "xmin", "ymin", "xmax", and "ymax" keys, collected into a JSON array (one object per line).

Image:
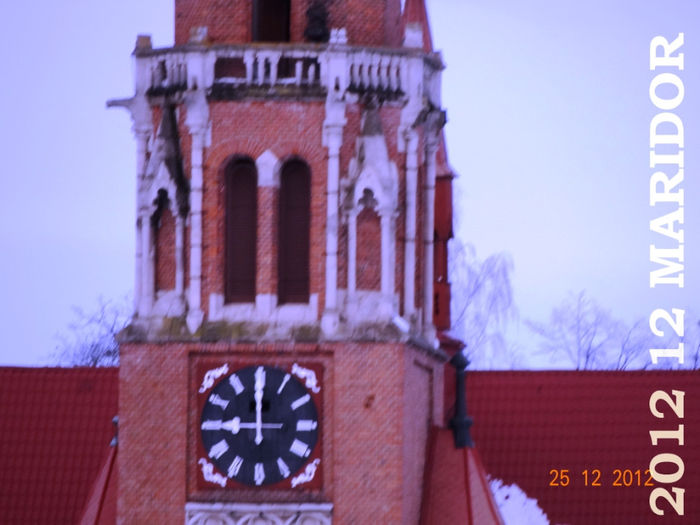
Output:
[{"xmin": 450, "ymin": 241, "xmax": 517, "ymax": 368}]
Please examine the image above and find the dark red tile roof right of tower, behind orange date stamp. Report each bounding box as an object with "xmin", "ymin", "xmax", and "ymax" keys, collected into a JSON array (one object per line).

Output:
[{"xmin": 467, "ymin": 371, "xmax": 700, "ymax": 525}]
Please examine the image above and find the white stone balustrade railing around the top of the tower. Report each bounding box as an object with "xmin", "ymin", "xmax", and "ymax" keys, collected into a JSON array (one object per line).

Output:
[{"xmin": 134, "ymin": 34, "xmax": 442, "ymax": 106}]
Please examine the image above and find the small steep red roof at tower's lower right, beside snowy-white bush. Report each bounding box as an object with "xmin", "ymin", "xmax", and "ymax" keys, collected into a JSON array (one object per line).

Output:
[{"xmin": 421, "ymin": 428, "xmax": 503, "ymax": 525}]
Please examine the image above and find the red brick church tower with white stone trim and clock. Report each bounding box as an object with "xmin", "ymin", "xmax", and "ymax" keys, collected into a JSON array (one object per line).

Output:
[{"xmin": 109, "ymin": 0, "xmax": 451, "ymax": 525}]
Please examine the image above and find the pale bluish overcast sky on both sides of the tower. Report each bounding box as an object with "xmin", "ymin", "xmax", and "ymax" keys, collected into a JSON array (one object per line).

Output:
[{"xmin": 0, "ymin": 0, "xmax": 700, "ymax": 365}]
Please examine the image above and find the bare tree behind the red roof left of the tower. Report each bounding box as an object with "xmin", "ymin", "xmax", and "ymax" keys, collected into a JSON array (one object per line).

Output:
[{"xmin": 54, "ymin": 298, "xmax": 129, "ymax": 366}]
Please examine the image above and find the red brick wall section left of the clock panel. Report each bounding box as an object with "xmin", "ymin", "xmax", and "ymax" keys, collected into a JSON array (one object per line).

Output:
[{"xmin": 117, "ymin": 345, "xmax": 187, "ymax": 525}]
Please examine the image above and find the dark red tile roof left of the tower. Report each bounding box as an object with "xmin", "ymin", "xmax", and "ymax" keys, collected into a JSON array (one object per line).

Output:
[{"xmin": 0, "ymin": 368, "xmax": 117, "ymax": 525}]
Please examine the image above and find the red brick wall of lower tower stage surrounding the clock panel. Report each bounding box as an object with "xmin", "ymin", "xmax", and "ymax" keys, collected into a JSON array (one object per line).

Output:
[{"xmin": 118, "ymin": 342, "xmax": 442, "ymax": 525}]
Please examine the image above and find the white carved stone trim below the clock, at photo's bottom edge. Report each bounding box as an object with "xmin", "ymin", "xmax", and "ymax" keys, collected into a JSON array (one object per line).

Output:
[{"xmin": 185, "ymin": 502, "xmax": 333, "ymax": 525}]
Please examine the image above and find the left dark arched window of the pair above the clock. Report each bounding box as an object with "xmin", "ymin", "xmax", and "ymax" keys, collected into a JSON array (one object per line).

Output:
[{"xmin": 224, "ymin": 158, "xmax": 258, "ymax": 303}]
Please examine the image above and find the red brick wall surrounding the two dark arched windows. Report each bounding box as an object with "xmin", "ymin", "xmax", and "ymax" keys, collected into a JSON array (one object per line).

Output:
[{"xmin": 202, "ymin": 101, "xmax": 328, "ymax": 310}]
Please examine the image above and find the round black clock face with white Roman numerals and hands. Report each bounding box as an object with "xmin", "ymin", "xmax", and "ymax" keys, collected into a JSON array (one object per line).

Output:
[{"xmin": 200, "ymin": 366, "xmax": 319, "ymax": 486}]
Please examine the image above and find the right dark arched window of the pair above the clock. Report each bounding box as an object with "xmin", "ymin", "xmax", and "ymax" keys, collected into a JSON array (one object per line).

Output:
[{"xmin": 277, "ymin": 159, "xmax": 311, "ymax": 304}]
